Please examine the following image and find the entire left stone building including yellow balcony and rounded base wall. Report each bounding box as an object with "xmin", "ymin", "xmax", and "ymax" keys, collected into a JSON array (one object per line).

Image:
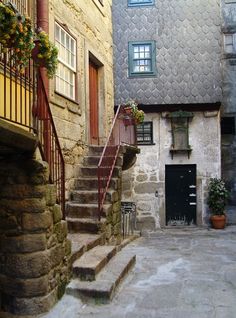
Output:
[{"xmin": 0, "ymin": 0, "xmax": 114, "ymax": 317}]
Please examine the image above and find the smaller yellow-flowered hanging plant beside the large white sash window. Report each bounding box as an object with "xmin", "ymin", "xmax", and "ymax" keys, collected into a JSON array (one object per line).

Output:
[{"xmin": 32, "ymin": 30, "xmax": 58, "ymax": 78}]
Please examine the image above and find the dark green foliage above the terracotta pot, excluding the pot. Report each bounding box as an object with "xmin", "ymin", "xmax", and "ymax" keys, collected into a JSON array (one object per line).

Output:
[{"xmin": 207, "ymin": 178, "xmax": 229, "ymax": 215}]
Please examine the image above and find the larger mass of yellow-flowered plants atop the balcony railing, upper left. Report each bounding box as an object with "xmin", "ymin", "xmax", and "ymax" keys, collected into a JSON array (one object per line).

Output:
[{"xmin": 0, "ymin": 2, "xmax": 34, "ymax": 69}]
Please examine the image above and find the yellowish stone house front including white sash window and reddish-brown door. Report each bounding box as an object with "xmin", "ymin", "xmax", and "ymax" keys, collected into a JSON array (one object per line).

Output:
[{"xmin": 49, "ymin": 0, "xmax": 114, "ymax": 197}]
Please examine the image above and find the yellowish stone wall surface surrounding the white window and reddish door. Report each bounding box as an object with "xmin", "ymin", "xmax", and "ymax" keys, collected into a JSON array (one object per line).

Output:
[{"xmin": 49, "ymin": 0, "xmax": 114, "ymax": 197}]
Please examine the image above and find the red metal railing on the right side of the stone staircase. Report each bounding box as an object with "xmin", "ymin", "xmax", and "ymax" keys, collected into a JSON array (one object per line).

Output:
[{"xmin": 98, "ymin": 106, "xmax": 136, "ymax": 219}]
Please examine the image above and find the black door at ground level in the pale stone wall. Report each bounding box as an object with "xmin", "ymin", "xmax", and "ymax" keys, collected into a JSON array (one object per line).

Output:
[{"xmin": 165, "ymin": 165, "xmax": 197, "ymax": 225}]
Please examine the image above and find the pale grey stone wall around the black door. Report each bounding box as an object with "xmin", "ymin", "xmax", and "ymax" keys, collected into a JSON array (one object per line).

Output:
[{"xmin": 123, "ymin": 112, "xmax": 221, "ymax": 230}]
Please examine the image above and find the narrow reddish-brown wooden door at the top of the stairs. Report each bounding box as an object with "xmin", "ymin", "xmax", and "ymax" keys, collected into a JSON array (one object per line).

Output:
[{"xmin": 89, "ymin": 61, "xmax": 99, "ymax": 144}]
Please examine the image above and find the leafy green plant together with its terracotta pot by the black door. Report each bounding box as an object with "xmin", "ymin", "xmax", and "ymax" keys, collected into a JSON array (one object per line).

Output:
[{"xmin": 207, "ymin": 178, "xmax": 229, "ymax": 229}]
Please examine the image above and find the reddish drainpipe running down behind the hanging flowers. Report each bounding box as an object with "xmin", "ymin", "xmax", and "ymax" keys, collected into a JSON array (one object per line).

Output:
[{"xmin": 37, "ymin": 0, "xmax": 49, "ymax": 96}]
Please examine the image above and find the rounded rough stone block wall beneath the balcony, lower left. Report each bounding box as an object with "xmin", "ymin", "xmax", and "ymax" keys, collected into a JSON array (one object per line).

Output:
[{"xmin": 0, "ymin": 155, "xmax": 70, "ymax": 316}]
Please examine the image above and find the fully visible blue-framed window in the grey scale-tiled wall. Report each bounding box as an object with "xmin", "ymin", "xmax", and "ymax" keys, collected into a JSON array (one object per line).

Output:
[{"xmin": 129, "ymin": 41, "xmax": 156, "ymax": 76}]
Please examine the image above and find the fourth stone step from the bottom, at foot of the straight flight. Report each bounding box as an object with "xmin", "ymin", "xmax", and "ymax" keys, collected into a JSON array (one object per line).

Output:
[{"xmin": 66, "ymin": 217, "xmax": 106, "ymax": 234}]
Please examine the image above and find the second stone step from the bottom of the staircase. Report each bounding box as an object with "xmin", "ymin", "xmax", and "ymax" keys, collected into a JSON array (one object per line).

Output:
[{"xmin": 72, "ymin": 245, "xmax": 116, "ymax": 281}]
